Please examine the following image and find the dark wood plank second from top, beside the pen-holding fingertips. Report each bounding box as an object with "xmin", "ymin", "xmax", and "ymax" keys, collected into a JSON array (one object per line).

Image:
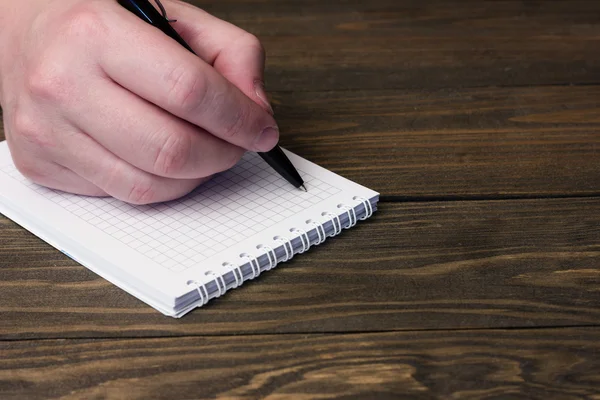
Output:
[{"xmin": 0, "ymin": 86, "xmax": 600, "ymax": 199}]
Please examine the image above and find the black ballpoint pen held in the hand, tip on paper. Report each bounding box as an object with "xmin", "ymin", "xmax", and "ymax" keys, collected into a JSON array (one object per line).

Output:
[{"xmin": 118, "ymin": 0, "xmax": 306, "ymax": 191}]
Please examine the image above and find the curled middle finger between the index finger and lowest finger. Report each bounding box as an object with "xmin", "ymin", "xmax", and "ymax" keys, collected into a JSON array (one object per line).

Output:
[{"xmin": 67, "ymin": 78, "xmax": 244, "ymax": 179}]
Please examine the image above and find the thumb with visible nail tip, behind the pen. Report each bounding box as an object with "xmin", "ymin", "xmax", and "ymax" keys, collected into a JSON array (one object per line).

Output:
[{"xmin": 165, "ymin": 2, "xmax": 273, "ymax": 114}]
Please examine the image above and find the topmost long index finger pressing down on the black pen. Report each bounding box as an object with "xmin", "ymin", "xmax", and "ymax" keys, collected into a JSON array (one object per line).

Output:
[{"xmin": 100, "ymin": 3, "xmax": 279, "ymax": 151}]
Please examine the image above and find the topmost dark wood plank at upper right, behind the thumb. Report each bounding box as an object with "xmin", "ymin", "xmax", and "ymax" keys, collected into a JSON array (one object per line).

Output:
[{"xmin": 183, "ymin": 0, "xmax": 600, "ymax": 91}]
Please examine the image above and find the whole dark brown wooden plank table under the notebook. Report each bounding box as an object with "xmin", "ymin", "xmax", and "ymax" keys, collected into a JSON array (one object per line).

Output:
[{"xmin": 0, "ymin": 0, "xmax": 600, "ymax": 399}]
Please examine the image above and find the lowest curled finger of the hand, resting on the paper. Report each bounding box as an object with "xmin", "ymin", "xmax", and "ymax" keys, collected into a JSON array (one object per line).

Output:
[{"xmin": 55, "ymin": 132, "xmax": 208, "ymax": 204}]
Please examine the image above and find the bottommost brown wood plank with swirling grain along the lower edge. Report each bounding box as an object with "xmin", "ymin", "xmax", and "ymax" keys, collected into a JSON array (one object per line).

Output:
[{"xmin": 0, "ymin": 328, "xmax": 600, "ymax": 400}]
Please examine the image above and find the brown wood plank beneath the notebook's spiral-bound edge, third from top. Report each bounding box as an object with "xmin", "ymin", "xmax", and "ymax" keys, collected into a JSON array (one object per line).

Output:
[{"xmin": 0, "ymin": 198, "xmax": 600, "ymax": 339}]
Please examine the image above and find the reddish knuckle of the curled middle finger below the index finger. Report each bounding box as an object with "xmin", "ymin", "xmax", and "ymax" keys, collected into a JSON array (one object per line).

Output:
[{"xmin": 154, "ymin": 134, "xmax": 192, "ymax": 176}]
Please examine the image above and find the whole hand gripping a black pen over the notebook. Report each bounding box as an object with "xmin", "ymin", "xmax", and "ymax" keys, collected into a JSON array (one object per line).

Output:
[{"xmin": 0, "ymin": 0, "xmax": 279, "ymax": 204}]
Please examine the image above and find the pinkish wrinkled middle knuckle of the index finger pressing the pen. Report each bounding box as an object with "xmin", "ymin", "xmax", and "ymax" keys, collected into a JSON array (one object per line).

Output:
[{"xmin": 166, "ymin": 67, "xmax": 207, "ymax": 113}]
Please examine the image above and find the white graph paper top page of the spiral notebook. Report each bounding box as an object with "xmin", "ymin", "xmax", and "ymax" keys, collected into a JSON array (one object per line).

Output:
[{"xmin": 0, "ymin": 143, "xmax": 376, "ymax": 306}]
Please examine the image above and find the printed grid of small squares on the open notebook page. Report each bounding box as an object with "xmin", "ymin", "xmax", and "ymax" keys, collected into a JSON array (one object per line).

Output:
[{"xmin": 0, "ymin": 153, "xmax": 341, "ymax": 272}]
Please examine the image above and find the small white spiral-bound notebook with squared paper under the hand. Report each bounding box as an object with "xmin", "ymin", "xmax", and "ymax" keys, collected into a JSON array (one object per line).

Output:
[{"xmin": 0, "ymin": 142, "xmax": 379, "ymax": 317}]
